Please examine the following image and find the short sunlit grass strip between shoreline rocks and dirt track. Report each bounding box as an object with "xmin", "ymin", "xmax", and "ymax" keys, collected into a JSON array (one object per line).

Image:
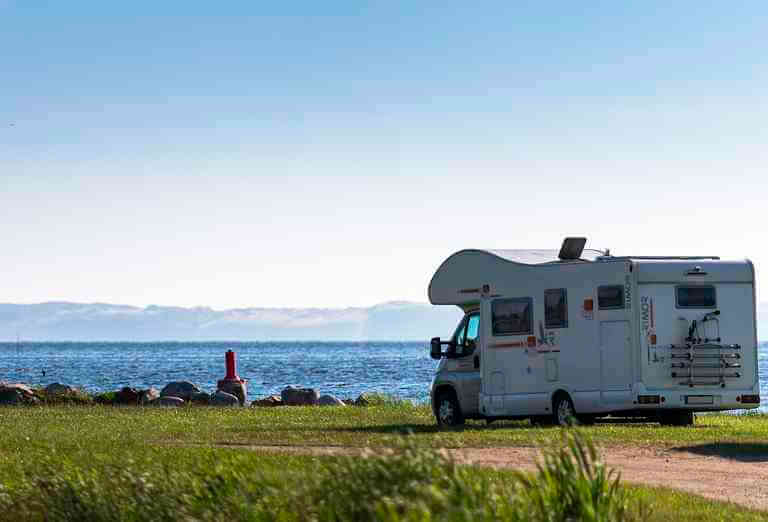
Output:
[{"xmin": 0, "ymin": 404, "xmax": 768, "ymax": 446}]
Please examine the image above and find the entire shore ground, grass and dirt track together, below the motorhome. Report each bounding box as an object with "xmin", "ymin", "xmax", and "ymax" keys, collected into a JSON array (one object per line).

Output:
[{"xmin": 0, "ymin": 395, "xmax": 768, "ymax": 521}]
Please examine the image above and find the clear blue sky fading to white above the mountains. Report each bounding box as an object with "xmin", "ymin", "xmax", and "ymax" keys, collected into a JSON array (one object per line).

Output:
[{"xmin": 0, "ymin": 0, "xmax": 768, "ymax": 308}]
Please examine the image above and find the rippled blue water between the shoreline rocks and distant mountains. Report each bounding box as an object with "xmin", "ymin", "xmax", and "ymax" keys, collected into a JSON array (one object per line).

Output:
[{"xmin": 0, "ymin": 342, "xmax": 768, "ymax": 411}]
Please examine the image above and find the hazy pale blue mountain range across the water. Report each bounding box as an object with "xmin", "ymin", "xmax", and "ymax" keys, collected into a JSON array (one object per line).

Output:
[{"xmin": 0, "ymin": 302, "xmax": 768, "ymax": 341}]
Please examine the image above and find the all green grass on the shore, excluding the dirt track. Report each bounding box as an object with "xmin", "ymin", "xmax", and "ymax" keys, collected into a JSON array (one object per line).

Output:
[{"xmin": 0, "ymin": 405, "xmax": 768, "ymax": 522}]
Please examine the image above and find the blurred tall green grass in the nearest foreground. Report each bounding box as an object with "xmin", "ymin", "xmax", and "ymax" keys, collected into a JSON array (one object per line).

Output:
[{"xmin": 0, "ymin": 428, "xmax": 638, "ymax": 522}]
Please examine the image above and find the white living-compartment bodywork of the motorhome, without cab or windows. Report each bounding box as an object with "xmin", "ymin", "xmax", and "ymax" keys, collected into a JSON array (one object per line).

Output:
[{"xmin": 429, "ymin": 250, "xmax": 759, "ymax": 417}]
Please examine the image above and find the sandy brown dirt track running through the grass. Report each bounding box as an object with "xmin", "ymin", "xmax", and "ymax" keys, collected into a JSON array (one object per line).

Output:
[{"xmin": 222, "ymin": 444, "xmax": 768, "ymax": 510}]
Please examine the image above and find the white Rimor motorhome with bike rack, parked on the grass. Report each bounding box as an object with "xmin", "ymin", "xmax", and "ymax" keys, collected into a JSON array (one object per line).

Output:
[{"xmin": 429, "ymin": 238, "xmax": 760, "ymax": 425}]
